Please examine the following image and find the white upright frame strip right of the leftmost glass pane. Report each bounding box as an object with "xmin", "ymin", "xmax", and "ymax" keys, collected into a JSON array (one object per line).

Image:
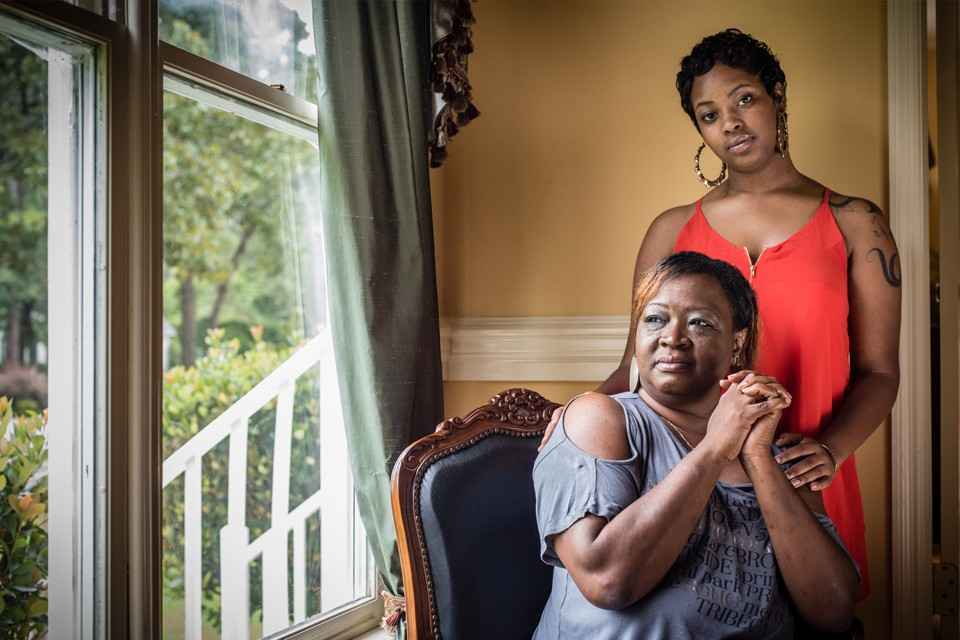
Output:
[{"xmin": 0, "ymin": 11, "xmax": 107, "ymax": 639}]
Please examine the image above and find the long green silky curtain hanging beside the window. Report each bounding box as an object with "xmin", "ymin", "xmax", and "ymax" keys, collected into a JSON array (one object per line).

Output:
[{"xmin": 314, "ymin": 0, "xmax": 443, "ymax": 620}]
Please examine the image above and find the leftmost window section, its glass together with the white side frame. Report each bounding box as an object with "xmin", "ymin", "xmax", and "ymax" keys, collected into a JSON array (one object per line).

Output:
[{"xmin": 0, "ymin": 13, "xmax": 103, "ymax": 638}]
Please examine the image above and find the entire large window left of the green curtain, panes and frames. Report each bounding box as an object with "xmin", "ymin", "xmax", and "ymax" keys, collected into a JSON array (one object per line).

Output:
[{"xmin": 0, "ymin": 0, "xmax": 379, "ymax": 640}]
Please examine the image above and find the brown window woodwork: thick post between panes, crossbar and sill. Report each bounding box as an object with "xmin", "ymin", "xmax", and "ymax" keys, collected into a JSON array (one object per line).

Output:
[{"xmin": 0, "ymin": 0, "xmax": 382, "ymax": 640}]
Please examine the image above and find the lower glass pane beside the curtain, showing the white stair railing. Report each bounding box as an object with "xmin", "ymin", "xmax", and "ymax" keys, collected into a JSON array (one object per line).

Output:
[{"xmin": 163, "ymin": 79, "xmax": 372, "ymax": 638}]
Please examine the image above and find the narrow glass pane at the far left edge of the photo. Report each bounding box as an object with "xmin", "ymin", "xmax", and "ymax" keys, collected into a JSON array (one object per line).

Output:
[{"xmin": 0, "ymin": 30, "xmax": 48, "ymax": 631}]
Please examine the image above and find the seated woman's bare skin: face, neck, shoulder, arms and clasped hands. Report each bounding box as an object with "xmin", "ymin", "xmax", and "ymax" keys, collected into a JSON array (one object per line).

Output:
[{"xmin": 554, "ymin": 276, "xmax": 857, "ymax": 631}]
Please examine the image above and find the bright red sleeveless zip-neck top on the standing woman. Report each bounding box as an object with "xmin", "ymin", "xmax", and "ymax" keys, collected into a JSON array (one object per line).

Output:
[{"xmin": 673, "ymin": 190, "xmax": 870, "ymax": 598}]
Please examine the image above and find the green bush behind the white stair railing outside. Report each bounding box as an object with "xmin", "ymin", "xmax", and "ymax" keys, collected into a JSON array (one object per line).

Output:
[{"xmin": 162, "ymin": 327, "xmax": 320, "ymax": 629}]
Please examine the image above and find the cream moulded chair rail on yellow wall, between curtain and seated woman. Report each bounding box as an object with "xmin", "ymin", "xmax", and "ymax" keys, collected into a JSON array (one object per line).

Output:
[{"xmin": 440, "ymin": 315, "xmax": 630, "ymax": 382}]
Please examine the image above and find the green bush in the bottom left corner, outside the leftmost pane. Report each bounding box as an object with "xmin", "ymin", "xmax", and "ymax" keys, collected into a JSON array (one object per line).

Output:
[{"xmin": 0, "ymin": 397, "xmax": 47, "ymax": 639}]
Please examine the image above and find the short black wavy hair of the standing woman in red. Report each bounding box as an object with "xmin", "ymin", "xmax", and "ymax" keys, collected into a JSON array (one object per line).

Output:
[{"xmin": 677, "ymin": 29, "xmax": 787, "ymax": 131}]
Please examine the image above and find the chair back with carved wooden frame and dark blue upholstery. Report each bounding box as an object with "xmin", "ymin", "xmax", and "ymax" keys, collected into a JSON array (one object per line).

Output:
[{"xmin": 392, "ymin": 389, "xmax": 558, "ymax": 640}]
